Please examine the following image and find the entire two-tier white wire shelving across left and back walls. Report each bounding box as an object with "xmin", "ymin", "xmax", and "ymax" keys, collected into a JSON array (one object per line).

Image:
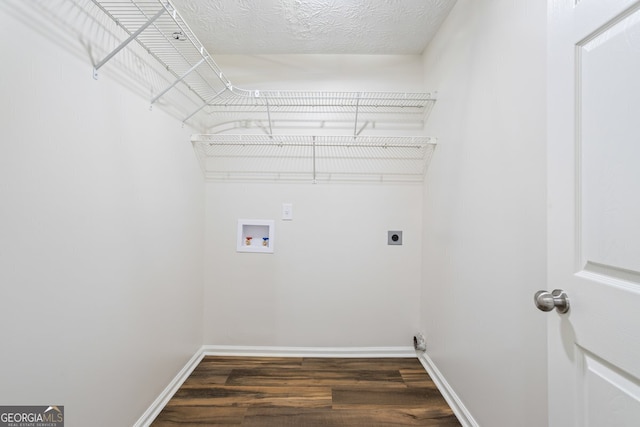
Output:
[{"xmin": 11, "ymin": 0, "xmax": 436, "ymax": 182}]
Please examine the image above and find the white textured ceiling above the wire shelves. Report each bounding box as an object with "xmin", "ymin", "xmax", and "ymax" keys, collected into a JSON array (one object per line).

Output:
[{"xmin": 173, "ymin": 0, "xmax": 456, "ymax": 55}]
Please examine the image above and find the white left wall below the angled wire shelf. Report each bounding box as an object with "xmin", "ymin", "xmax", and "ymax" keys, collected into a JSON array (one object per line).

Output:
[{"xmin": 0, "ymin": 8, "xmax": 204, "ymax": 426}]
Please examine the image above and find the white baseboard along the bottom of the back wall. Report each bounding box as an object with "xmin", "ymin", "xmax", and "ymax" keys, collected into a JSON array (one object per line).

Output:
[{"xmin": 202, "ymin": 345, "xmax": 416, "ymax": 357}]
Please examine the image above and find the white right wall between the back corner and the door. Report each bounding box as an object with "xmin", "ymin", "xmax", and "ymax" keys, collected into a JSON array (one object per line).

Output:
[{"xmin": 421, "ymin": 0, "xmax": 547, "ymax": 427}]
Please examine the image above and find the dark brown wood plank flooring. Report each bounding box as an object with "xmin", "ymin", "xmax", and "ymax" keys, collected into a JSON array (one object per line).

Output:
[{"xmin": 152, "ymin": 356, "xmax": 460, "ymax": 427}]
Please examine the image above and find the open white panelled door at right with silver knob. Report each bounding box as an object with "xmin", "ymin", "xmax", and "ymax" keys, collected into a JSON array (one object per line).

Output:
[{"xmin": 541, "ymin": 0, "xmax": 640, "ymax": 427}]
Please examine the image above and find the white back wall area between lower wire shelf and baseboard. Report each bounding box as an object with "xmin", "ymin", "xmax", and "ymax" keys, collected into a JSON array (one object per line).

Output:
[{"xmin": 204, "ymin": 183, "xmax": 422, "ymax": 347}]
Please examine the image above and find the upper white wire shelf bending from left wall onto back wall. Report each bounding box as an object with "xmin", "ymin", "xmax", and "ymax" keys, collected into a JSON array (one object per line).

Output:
[{"xmin": 92, "ymin": 0, "xmax": 435, "ymax": 131}]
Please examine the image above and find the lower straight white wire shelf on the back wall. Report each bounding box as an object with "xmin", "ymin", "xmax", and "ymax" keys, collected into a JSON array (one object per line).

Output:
[{"xmin": 191, "ymin": 134, "xmax": 436, "ymax": 182}]
